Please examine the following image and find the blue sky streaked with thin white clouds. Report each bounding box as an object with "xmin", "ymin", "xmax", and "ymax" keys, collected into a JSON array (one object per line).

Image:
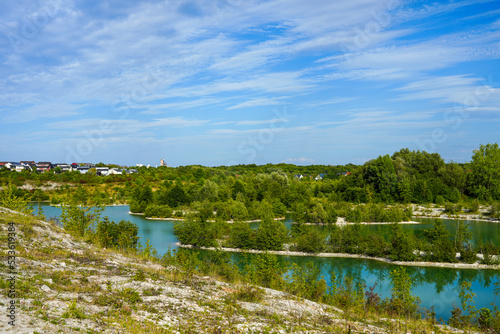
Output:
[{"xmin": 0, "ymin": 0, "xmax": 500, "ymax": 166}]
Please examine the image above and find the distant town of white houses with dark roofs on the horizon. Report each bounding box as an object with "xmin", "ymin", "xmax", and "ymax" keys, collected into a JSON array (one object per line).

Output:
[{"xmin": 0, "ymin": 159, "xmax": 170, "ymax": 176}]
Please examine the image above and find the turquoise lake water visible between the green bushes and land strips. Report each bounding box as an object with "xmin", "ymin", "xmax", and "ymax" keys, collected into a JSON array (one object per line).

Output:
[{"xmin": 35, "ymin": 205, "xmax": 500, "ymax": 320}]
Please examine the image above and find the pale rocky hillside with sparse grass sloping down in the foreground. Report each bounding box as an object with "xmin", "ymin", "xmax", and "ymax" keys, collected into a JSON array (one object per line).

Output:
[{"xmin": 0, "ymin": 208, "xmax": 472, "ymax": 333}]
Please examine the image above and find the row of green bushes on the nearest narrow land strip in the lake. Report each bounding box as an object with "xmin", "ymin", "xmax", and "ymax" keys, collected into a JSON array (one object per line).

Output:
[{"xmin": 174, "ymin": 211, "xmax": 500, "ymax": 264}]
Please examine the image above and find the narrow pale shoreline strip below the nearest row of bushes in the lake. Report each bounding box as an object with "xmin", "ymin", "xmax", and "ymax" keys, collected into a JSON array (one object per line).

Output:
[{"xmin": 176, "ymin": 242, "xmax": 500, "ymax": 270}]
